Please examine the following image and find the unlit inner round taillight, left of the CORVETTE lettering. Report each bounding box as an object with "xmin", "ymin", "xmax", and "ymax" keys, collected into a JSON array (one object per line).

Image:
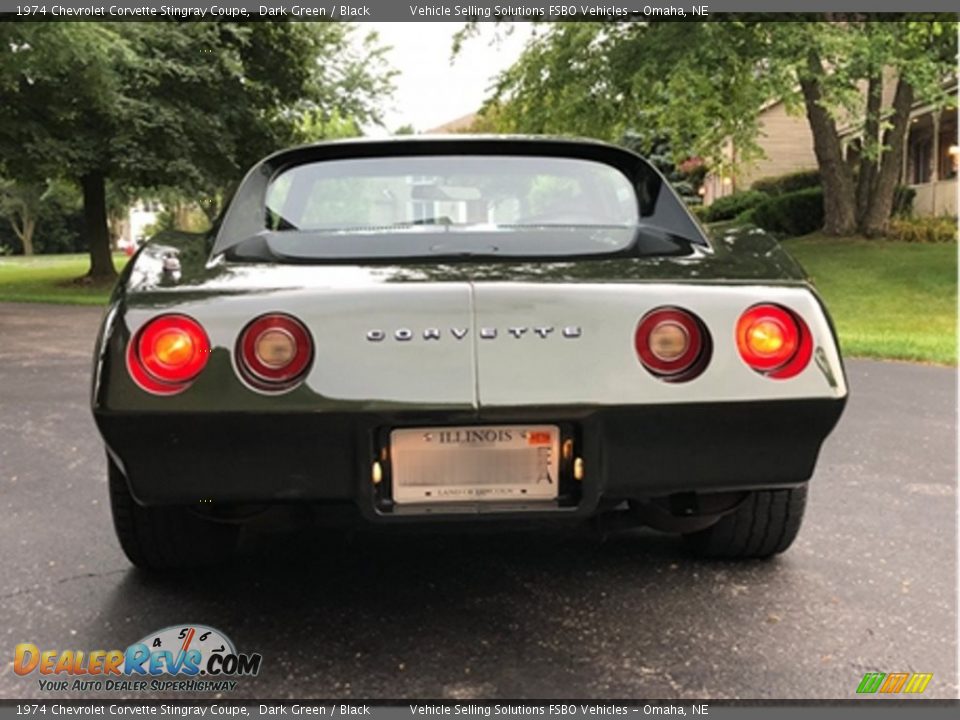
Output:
[{"xmin": 238, "ymin": 313, "xmax": 313, "ymax": 390}]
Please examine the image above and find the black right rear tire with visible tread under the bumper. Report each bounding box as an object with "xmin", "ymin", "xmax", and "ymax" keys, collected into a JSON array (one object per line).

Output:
[{"xmin": 685, "ymin": 485, "xmax": 807, "ymax": 559}]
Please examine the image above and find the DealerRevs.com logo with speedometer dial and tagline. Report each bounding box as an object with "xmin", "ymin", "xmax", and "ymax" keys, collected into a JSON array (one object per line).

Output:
[{"xmin": 13, "ymin": 624, "xmax": 263, "ymax": 692}]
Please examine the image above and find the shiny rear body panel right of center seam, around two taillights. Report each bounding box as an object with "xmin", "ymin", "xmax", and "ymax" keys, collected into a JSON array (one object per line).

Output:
[{"xmin": 474, "ymin": 283, "xmax": 847, "ymax": 406}]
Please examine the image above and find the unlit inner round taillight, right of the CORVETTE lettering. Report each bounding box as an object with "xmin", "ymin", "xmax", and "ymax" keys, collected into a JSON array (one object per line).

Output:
[{"xmin": 634, "ymin": 307, "xmax": 709, "ymax": 381}]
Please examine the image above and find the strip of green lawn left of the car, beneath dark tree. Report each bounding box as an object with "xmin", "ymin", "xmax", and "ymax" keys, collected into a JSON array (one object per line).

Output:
[{"xmin": 0, "ymin": 254, "xmax": 127, "ymax": 305}]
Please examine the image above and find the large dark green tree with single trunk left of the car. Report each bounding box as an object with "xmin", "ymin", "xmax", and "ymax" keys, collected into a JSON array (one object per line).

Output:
[{"xmin": 0, "ymin": 22, "xmax": 391, "ymax": 279}]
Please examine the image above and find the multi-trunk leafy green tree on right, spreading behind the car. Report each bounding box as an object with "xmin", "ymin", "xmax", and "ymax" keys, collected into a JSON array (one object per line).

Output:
[{"xmin": 476, "ymin": 19, "xmax": 957, "ymax": 235}]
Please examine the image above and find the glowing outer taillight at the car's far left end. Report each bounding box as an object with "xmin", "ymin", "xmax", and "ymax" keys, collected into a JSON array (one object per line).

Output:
[{"xmin": 127, "ymin": 315, "xmax": 210, "ymax": 395}]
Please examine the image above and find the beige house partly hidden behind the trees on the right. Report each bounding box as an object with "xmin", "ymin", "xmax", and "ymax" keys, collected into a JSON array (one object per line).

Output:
[{"xmin": 703, "ymin": 77, "xmax": 960, "ymax": 215}]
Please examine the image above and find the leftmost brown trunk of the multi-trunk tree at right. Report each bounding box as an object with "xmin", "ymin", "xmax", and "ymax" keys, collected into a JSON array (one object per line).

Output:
[{"xmin": 800, "ymin": 53, "xmax": 857, "ymax": 235}]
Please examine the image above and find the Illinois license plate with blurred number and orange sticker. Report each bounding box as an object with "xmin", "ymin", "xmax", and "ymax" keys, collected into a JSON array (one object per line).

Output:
[{"xmin": 390, "ymin": 425, "xmax": 560, "ymax": 504}]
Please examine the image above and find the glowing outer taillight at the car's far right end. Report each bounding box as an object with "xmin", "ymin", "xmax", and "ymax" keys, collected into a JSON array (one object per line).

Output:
[{"xmin": 737, "ymin": 305, "xmax": 813, "ymax": 379}]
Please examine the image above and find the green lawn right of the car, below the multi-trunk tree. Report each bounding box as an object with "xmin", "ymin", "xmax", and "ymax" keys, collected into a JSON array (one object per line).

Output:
[{"xmin": 783, "ymin": 233, "xmax": 957, "ymax": 365}]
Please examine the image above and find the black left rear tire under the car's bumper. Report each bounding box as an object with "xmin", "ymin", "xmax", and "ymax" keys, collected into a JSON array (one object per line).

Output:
[{"xmin": 107, "ymin": 459, "xmax": 240, "ymax": 570}]
